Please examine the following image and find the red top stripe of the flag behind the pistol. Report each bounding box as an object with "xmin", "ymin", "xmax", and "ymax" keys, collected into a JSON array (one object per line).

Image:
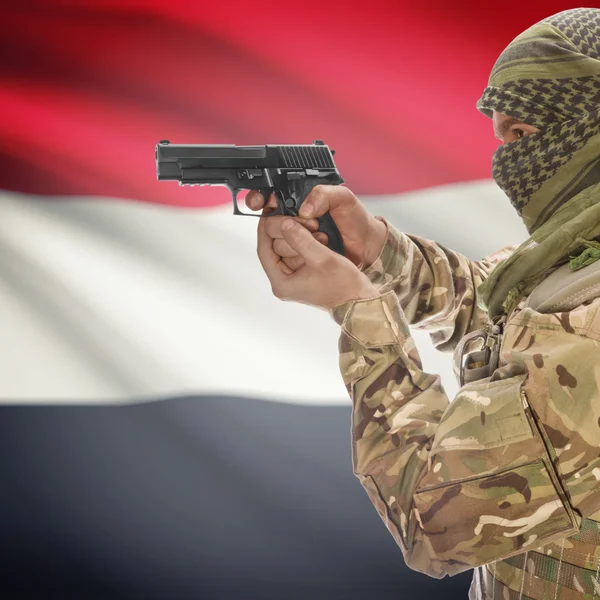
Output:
[{"xmin": 0, "ymin": 0, "xmax": 580, "ymax": 205}]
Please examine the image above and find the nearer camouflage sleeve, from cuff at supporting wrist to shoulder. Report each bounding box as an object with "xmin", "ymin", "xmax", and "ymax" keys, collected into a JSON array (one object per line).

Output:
[{"xmin": 332, "ymin": 291, "xmax": 578, "ymax": 578}]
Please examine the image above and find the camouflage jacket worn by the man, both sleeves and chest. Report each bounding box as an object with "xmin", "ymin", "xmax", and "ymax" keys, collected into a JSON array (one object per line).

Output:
[{"xmin": 331, "ymin": 218, "xmax": 600, "ymax": 584}]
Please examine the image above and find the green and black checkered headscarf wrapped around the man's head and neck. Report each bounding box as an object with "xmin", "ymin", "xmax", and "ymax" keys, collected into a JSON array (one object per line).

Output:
[{"xmin": 477, "ymin": 8, "xmax": 600, "ymax": 317}]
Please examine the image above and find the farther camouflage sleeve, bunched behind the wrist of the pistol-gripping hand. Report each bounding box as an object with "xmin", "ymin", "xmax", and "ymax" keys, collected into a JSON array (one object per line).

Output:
[{"xmin": 364, "ymin": 217, "xmax": 515, "ymax": 351}]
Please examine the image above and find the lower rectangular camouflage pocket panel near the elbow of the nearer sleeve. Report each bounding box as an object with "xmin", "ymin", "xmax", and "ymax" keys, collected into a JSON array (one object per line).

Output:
[{"xmin": 414, "ymin": 459, "xmax": 577, "ymax": 575}]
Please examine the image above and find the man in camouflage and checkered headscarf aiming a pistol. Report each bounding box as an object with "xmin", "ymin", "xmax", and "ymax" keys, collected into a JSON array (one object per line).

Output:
[{"xmin": 247, "ymin": 9, "xmax": 600, "ymax": 599}]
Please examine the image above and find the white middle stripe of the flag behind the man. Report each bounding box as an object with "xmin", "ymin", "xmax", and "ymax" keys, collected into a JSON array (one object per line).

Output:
[{"xmin": 0, "ymin": 181, "xmax": 524, "ymax": 404}]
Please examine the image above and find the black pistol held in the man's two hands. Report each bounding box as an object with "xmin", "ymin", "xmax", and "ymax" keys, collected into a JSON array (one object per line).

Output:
[{"xmin": 156, "ymin": 140, "xmax": 344, "ymax": 254}]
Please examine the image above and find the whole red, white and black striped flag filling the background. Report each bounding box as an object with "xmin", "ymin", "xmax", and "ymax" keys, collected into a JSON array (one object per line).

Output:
[{"xmin": 0, "ymin": 0, "xmax": 592, "ymax": 600}]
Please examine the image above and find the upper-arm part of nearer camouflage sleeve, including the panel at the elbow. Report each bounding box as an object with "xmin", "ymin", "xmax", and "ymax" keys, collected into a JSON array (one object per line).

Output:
[{"xmin": 414, "ymin": 375, "xmax": 578, "ymax": 574}]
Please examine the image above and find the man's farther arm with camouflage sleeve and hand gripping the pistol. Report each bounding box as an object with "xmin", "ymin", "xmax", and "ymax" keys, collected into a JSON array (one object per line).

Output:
[{"xmin": 246, "ymin": 185, "xmax": 512, "ymax": 350}]
